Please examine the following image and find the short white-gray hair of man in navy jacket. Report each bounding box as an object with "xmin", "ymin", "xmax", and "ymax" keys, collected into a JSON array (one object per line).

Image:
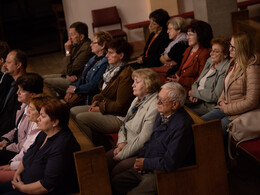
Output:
[{"xmin": 161, "ymin": 82, "xmax": 186, "ymax": 107}]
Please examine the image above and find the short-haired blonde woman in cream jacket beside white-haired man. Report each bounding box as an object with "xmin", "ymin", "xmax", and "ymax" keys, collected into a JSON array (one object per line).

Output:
[{"xmin": 107, "ymin": 68, "xmax": 160, "ymax": 177}]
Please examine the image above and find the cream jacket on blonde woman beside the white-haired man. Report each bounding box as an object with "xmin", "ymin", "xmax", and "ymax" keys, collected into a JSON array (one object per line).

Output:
[{"xmin": 117, "ymin": 93, "xmax": 158, "ymax": 160}]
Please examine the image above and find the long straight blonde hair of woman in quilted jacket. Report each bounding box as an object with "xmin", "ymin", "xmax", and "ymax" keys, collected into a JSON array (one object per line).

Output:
[{"xmin": 231, "ymin": 32, "xmax": 254, "ymax": 80}]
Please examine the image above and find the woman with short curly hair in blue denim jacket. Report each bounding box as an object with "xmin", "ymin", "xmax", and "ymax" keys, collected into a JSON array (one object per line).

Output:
[{"xmin": 64, "ymin": 31, "xmax": 112, "ymax": 106}]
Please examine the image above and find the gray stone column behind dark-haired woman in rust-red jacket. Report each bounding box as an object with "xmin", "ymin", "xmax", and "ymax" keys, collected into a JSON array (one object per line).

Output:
[{"xmin": 193, "ymin": 0, "xmax": 237, "ymax": 37}]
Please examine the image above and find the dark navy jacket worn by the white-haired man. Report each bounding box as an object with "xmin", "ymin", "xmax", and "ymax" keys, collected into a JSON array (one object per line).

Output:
[{"xmin": 139, "ymin": 108, "xmax": 194, "ymax": 172}]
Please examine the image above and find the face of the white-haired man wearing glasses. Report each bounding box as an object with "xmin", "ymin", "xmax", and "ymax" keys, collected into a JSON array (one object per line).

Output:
[{"xmin": 156, "ymin": 89, "xmax": 175, "ymax": 116}]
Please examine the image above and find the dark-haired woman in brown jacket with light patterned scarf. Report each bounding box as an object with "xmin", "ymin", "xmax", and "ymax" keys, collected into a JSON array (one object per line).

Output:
[{"xmin": 71, "ymin": 39, "xmax": 134, "ymax": 142}]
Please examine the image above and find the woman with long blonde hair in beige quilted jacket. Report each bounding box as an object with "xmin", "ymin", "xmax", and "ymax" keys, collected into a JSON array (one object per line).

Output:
[{"xmin": 202, "ymin": 32, "xmax": 260, "ymax": 144}]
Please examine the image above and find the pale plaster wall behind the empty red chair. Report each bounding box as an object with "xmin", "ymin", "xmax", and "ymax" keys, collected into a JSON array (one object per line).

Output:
[{"xmin": 63, "ymin": 0, "xmax": 151, "ymax": 42}]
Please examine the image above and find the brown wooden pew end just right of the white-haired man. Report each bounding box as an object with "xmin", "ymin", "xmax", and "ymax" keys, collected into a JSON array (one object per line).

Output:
[{"xmin": 155, "ymin": 109, "xmax": 228, "ymax": 195}]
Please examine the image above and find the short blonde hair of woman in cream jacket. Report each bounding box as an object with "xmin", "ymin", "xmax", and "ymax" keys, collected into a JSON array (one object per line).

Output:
[{"xmin": 132, "ymin": 68, "xmax": 161, "ymax": 93}]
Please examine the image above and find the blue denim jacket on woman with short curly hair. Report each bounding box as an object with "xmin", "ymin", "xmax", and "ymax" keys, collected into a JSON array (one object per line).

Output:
[{"xmin": 71, "ymin": 56, "xmax": 108, "ymax": 102}]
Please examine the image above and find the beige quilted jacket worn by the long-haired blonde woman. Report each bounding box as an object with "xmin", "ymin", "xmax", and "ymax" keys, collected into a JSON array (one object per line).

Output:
[{"xmin": 218, "ymin": 54, "xmax": 260, "ymax": 120}]
